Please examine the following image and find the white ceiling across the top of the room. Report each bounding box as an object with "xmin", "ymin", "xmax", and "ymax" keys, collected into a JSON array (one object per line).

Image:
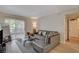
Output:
[{"xmin": 0, "ymin": 5, "xmax": 79, "ymax": 17}]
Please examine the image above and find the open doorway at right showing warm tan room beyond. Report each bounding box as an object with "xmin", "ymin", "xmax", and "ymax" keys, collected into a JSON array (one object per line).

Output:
[{"xmin": 65, "ymin": 14, "xmax": 79, "ymax": 44}]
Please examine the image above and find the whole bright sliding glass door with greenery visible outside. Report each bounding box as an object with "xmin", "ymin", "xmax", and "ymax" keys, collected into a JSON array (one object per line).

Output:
[{"xmin": 5, "ymin": 18, "xmax": 25, "ymax": 39}]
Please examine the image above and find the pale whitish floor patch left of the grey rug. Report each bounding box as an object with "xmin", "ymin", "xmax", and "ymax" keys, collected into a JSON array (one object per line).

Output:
[{"xmin": 6, "ymin": 40, "xmax": 21, "ymax": 53}]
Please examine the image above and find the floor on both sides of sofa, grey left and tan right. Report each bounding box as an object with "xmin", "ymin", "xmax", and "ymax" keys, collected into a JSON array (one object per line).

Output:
[{"xmin": 6, "ymin": 38, "xmax": 79, "ymax": 53}]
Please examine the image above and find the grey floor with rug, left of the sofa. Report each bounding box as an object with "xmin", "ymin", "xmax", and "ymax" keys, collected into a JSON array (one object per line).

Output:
[{"xmin": 6, "ymin": 40, "xmax": 36, "ymax": 53}]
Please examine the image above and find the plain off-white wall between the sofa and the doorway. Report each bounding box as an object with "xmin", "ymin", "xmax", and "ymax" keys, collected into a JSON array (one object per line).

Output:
[{"xmin": 38, "ymin": 14, "xmax": 64, "ymax": 43}]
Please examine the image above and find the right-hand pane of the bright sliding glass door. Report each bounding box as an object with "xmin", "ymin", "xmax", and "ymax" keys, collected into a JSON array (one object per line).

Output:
[{"xmin": 15, "ymin": 20, "xmax": 25, "ymax": 39}]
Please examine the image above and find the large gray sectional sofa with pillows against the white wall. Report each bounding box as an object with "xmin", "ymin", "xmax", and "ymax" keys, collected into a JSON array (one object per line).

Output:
[{"xmin": 32, "ymin": 30, "xmax": 60, "ymax": 53}]
